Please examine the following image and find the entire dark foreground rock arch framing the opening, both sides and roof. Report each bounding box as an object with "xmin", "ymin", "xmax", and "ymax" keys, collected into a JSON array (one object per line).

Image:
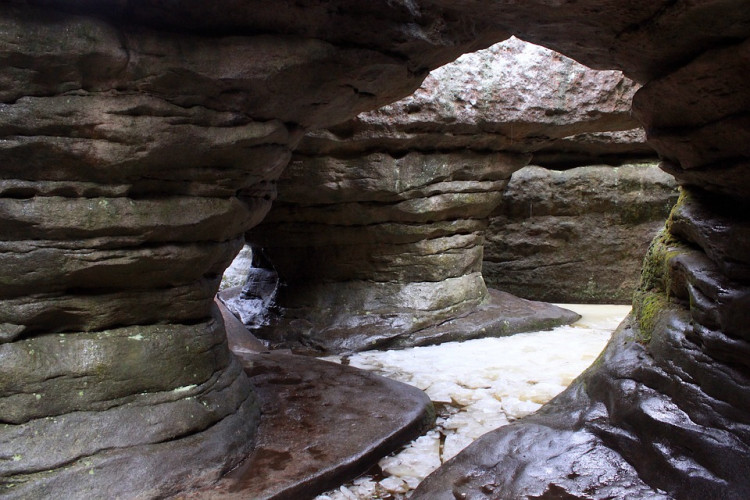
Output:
[{"xmin": 0, "ymin": 0, "xmax": 750, "ymax": 500}]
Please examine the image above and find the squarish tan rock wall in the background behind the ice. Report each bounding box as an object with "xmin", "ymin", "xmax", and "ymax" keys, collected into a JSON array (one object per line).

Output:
[{"xmin": 482, "ymin": 163, "xmax": 677, "ymax": 304}]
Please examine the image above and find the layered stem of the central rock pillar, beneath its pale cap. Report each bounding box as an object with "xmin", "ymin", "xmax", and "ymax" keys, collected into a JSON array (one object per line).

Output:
[{"xmin": 247, "ymin": 153, "xmax": 527, "ymax": 352}]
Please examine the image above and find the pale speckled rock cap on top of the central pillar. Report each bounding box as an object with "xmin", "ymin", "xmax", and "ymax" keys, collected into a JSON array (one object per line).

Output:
[{"xmin": 297, "ymin": 38, "xmax": 642, "ymax": 156}]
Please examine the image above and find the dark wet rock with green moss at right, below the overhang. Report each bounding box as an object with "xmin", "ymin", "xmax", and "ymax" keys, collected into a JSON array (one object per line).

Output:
[{"xmin": 413, "ymin": 190, "xmax": 750, "ymax": 500}]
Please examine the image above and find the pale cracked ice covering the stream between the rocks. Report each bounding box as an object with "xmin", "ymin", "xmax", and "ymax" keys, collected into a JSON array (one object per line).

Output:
[{"xmin": 316, "ymin": 304, "xmax": 630, "ymax": 500}]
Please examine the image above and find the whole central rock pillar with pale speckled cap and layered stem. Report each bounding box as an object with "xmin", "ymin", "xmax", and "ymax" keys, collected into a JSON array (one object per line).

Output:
[{"xmin": 245, "ymin": 39, "xmax": 645, "ymax": 352}]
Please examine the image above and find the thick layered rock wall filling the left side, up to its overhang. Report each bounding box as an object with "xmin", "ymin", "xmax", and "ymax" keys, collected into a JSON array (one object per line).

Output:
[{"xmin": 0, "ymin": 1, "xmax": 500, "ymax": 498}]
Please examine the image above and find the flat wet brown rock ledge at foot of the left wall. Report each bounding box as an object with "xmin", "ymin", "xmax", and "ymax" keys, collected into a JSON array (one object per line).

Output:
[{"xmin": 180, "ymin": 312, "xmax": 435, "ymax": 500}]
